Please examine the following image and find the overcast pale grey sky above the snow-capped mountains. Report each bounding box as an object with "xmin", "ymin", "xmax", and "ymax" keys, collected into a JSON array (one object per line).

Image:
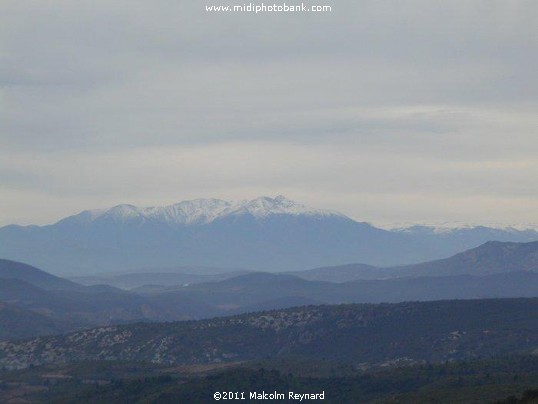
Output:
[{"xmin": 0, "ymin": 0, "xmax": 538, "ymax": 225}]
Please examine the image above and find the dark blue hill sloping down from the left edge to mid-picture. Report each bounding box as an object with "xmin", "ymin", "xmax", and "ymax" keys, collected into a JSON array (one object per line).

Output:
[{"xmin": 0, "ymin": 260, "xmax": 218, "ymax": 336}]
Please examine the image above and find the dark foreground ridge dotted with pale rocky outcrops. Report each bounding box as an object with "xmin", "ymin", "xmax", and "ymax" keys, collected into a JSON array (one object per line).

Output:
[{"xmin": 0, "ymin": 299, "xmax": 538, "ymax": 369}]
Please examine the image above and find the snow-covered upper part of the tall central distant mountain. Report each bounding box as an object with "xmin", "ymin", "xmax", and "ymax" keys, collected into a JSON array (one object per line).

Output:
[{"xmin": 57, "ymin": 195, "xmax": 346, "ymax": 225}]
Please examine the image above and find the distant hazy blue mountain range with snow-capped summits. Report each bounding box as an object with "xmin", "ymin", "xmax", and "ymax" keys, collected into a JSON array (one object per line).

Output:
[{"xmin": 0, "ymin": 196, "xmax": 538, "ymax": 275}]
